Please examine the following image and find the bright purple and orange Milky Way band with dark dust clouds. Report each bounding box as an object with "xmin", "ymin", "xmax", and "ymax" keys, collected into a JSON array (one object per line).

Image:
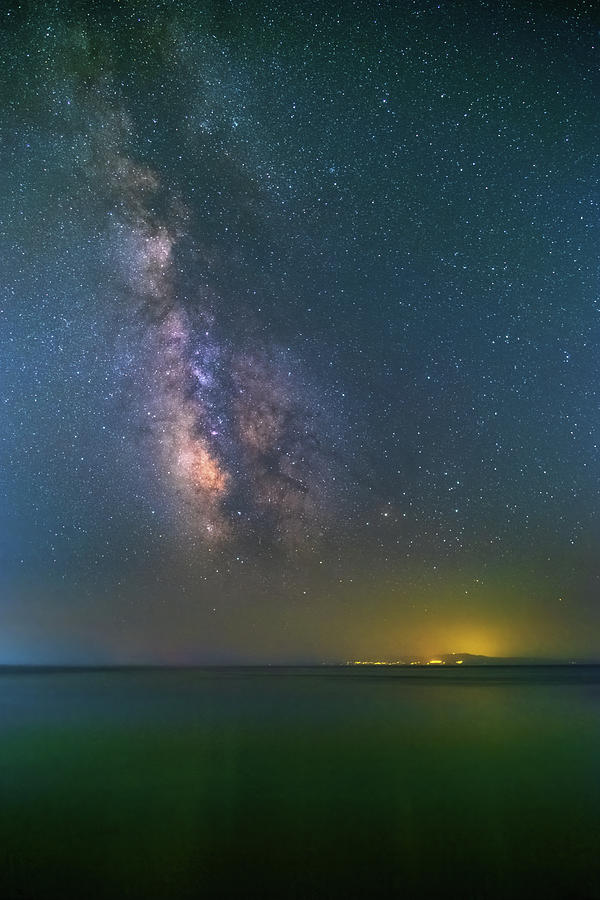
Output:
[{"xmin": 88, "ymin": 88, "xmax": 343, "ymax": 548}]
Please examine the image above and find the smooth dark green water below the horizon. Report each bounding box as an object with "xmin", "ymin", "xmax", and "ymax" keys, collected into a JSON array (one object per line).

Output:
[{"xmin": 0, "ymin": 667, "xmax": 600, "ymax": 900}]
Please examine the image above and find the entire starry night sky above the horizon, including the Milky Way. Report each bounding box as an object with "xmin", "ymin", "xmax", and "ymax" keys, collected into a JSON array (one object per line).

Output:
[{"xmin": 0, "ymin": 0, "xmax": 600, "ymax": 663}]
